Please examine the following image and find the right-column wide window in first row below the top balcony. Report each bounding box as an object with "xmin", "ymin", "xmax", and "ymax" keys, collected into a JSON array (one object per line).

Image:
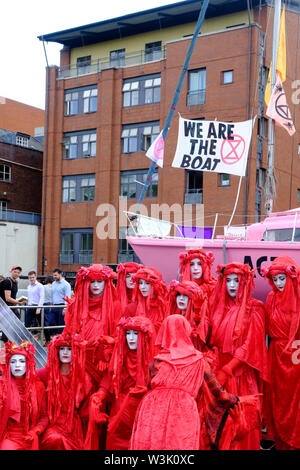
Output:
[{"xmin": 122, "ymin": 74, "xmax": 161, "ymax": 108}]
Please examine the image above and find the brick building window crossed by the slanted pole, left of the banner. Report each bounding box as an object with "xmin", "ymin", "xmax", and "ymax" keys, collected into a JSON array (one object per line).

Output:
[{"xmin": 120, "ymin": 170, "xmax": 158, "ymax": 199}]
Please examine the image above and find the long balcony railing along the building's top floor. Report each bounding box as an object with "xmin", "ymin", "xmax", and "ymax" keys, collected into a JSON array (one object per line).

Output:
[{"xmin": 58, "ymin": 46, "xmax": 166, "ymax": 79}]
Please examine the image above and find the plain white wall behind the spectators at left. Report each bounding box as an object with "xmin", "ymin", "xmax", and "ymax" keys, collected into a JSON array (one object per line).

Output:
[{"xmin": 0, "ymin": 220, "xmax": 39, "ymax": 287}]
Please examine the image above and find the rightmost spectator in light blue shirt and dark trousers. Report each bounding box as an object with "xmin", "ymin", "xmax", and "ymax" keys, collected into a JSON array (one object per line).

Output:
[{"xmin": 50, "ymin": 268, "xmax": 71, "ymax": 336}]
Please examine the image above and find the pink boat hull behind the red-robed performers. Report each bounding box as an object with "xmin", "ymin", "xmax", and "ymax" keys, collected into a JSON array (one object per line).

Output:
[{"xmin": 127, "ymin": 237, "xmax": 300, "ymax": 301}]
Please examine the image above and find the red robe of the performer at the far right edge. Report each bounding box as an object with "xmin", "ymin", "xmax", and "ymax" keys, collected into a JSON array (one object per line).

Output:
[{"xmin": 265, "ymin": 292, "xmax": 300, "ymax": 449}]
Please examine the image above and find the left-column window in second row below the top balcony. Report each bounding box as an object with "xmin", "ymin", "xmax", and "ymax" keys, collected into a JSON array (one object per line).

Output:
[{"xmin": 62, "ymin": 130, "xmax": 97, "ymax": 160}]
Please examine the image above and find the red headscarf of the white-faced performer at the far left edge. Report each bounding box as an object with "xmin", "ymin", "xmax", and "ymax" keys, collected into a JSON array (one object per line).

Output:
[{"xmin": 0, "ymin": 341, "xmax": 39, "ymax": 440}]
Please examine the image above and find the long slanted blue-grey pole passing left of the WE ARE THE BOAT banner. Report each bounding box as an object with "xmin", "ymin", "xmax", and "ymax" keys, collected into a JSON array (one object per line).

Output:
[{"xmin": 135, "ymin": 0, "xmax": 209, "ymax": 214}]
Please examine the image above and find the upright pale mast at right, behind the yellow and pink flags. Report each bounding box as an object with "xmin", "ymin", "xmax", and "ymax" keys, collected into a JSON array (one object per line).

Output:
[{"xmin": 265, "ymin": 0, "xmax": 281, "ymax": 216}]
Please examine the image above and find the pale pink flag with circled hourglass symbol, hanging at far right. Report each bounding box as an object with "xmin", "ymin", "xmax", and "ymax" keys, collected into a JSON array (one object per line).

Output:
[{"xmin": 266, "ymin": 74, "xmax": 296, "ymax": 135}]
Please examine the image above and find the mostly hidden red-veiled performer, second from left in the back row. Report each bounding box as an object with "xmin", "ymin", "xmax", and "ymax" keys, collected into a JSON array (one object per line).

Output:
[{"xmin": 116, "ymin": 261, "xmax": 142, "ymax": 316}]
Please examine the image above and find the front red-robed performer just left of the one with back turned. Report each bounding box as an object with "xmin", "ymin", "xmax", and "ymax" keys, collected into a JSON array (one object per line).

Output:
[{"xmin": 84, "ymin": 317, "xmax": 155, "ymax": 450}]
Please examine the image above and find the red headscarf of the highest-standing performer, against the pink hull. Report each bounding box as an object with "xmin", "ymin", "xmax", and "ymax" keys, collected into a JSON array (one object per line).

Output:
[{"xmin": 179, "ymin": 249, "xmax": 215, "ymax": 285}]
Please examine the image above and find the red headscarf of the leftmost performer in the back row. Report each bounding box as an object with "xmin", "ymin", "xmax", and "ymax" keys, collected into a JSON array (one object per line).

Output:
[{"xmin": 65, "ymin": 264, "xmax": 120, "ymax": 335}]
